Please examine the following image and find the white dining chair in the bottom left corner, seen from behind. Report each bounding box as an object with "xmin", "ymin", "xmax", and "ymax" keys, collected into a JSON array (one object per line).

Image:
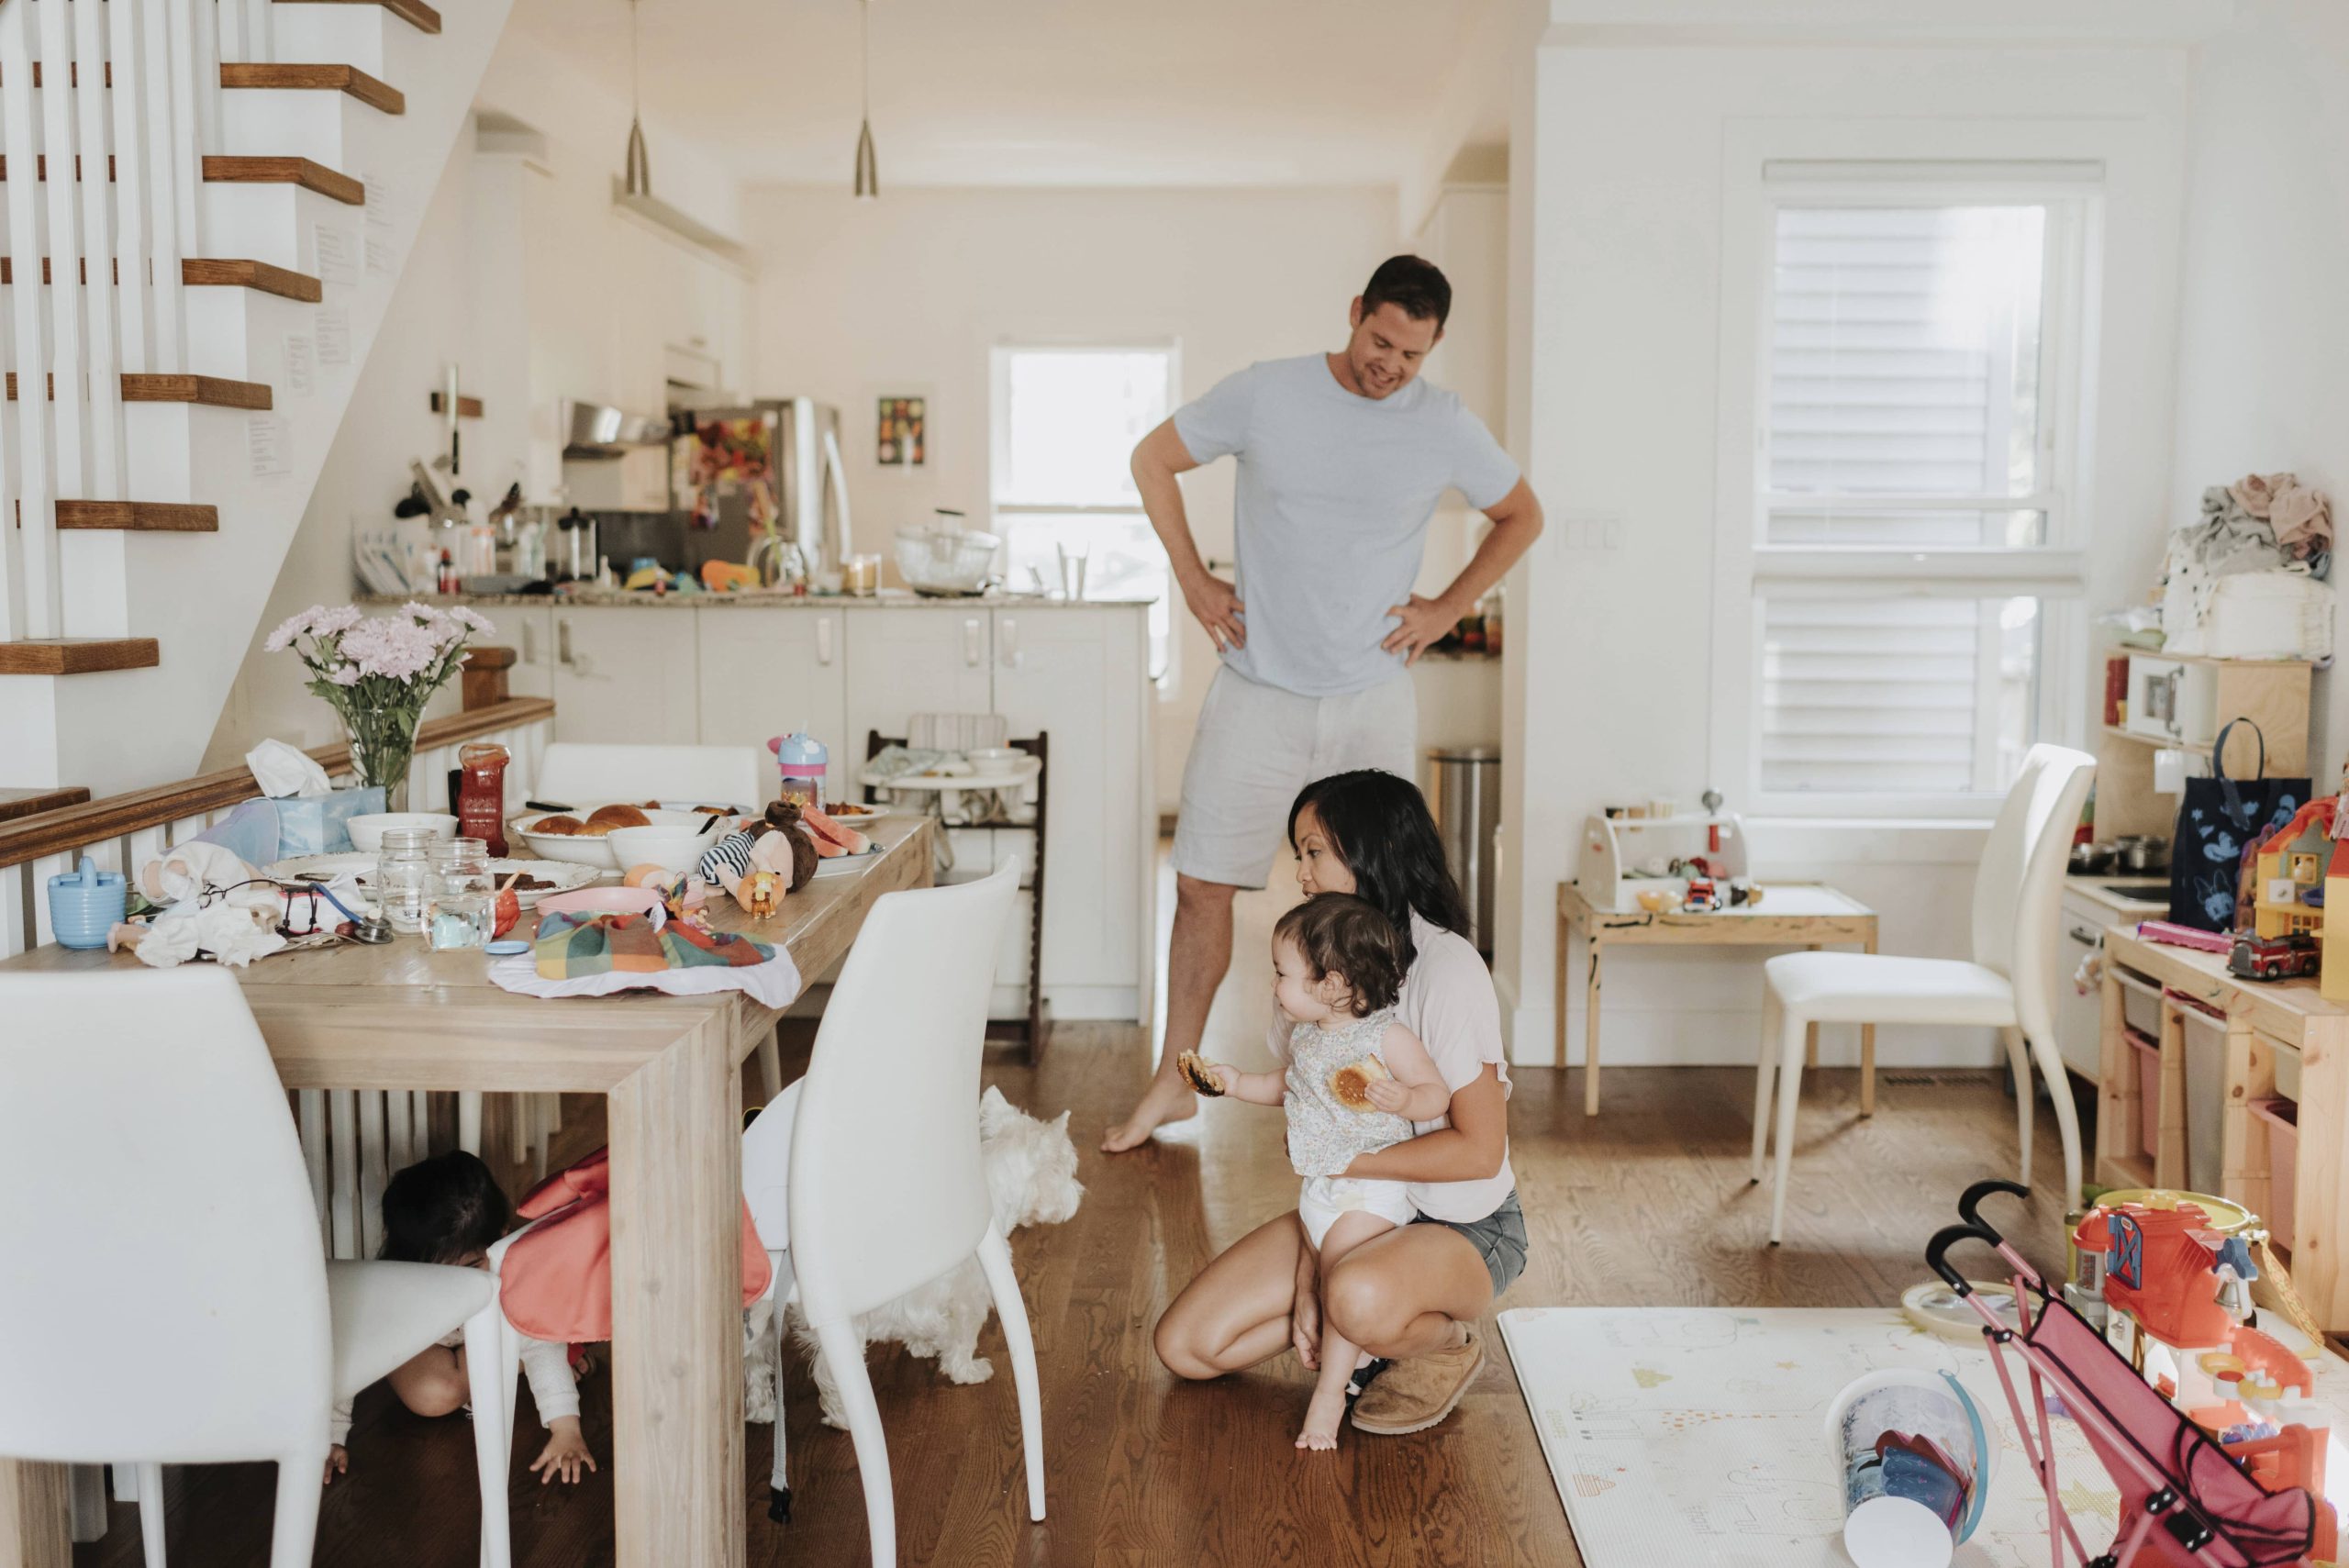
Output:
[{"xmin": 0, "ymin": 964, "xmax": 507, "ymax": 1568}]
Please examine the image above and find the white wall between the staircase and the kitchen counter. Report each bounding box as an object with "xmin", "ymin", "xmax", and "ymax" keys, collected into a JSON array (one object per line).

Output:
[{"xmin": 205, "ymin": 28, "xmax": 751, "ymax": 770}]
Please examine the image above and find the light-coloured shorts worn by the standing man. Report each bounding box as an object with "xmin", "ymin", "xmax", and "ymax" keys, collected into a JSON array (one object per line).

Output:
[{"xmin": 1174, "ymin": 669, "xmax": 1419, "ymax": 887}]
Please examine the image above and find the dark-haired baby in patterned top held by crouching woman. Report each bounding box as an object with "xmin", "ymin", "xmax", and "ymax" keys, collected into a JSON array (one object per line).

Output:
[{"xmin": 1186, "ymin": 892, "xmax": 1452, "ymax": 1449}]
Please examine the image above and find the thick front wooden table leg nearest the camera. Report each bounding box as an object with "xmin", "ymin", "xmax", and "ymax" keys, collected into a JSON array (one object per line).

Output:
[{"xmin": 608, "ymin": 1007, "xmax": 745, "ymax": 1568}]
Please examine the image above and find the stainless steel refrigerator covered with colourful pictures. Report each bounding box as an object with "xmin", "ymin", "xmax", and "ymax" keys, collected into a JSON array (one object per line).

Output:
[{"xmin": 670, "ymin": 396, "xmax": 851, "ymax": 575}]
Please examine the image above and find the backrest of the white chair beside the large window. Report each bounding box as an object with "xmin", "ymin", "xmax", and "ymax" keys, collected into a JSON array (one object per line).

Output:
[{"xmin": 1973, "ymin": 744, "xmax": 2096, "ymax": 1040}]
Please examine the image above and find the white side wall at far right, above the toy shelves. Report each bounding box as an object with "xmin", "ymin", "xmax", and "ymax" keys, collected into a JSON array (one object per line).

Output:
[{"xmin": 2164, "ymin": 0, "xmax": 2349, "ymax": 789}]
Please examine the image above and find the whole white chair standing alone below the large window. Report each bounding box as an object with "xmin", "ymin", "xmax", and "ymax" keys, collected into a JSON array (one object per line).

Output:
[{"xmin": 1753, "ymin": 744, "xmax": 2096, "ymax": 1247}]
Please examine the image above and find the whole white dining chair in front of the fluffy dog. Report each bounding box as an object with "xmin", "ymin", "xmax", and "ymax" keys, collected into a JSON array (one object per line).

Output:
[{"xmin": 770, "ymin": 859, "xmax": 1043, "ymax": 1568}]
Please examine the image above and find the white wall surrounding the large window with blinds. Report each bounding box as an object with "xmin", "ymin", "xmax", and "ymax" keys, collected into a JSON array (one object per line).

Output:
[{"xmin": 1497, "ymin": 33, "xmax": 2187, "ymax": 1063}]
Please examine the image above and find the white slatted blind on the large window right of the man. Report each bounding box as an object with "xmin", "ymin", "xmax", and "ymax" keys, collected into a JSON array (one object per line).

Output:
[{"xmin": 1750, "ymin": 190, "xmax": 2076, "ymax": 798}]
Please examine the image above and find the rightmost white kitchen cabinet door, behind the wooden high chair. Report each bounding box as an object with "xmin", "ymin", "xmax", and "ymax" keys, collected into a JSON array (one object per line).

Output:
[{"xmin": 994, "ymin": 608, "xmax": 1151, "ymax": 999}]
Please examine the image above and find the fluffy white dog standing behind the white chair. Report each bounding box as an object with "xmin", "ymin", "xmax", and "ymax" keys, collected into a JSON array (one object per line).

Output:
[{"xmin": 742, "ymin": 1084, "xmax": 1085, "ymax": 1427}]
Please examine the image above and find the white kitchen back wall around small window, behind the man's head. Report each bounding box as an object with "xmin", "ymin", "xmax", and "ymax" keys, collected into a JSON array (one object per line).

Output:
[{"xmin": 742, "ymin": 178, "xmax": 1390, "ymax": 810}]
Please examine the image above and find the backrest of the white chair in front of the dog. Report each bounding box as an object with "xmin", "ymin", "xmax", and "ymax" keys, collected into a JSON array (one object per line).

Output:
[{"xmin": 789, "ymin": 862, "xmax": 1019, "ymax": 1321}]
